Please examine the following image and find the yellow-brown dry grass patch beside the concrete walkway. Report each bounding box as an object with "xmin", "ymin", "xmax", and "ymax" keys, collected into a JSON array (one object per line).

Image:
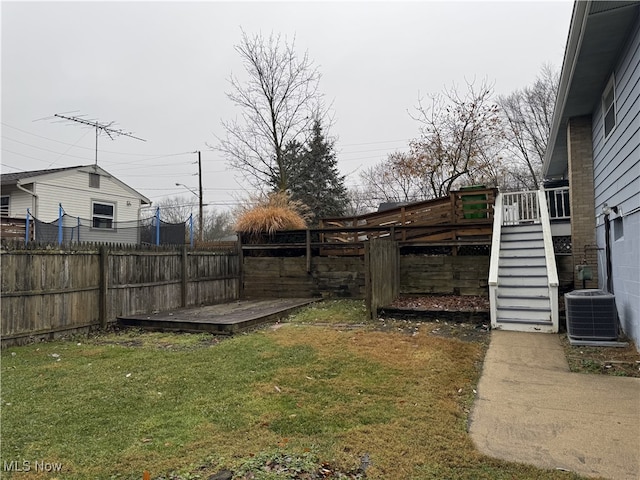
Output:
[{"xmin": 264, "ymin": 326, "xmax": 483, "ymax": 478}]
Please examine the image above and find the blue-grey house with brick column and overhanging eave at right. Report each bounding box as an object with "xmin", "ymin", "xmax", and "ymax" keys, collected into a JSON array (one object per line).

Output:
[{"xmin": 544, "ymin": 1, "xmax": 640, "ymax": 349}]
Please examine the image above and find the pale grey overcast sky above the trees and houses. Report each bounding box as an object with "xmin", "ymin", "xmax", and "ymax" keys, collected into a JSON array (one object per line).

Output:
[{"xmin": 1, "ymin": 0, "xmax": 573, "ymax": 214}]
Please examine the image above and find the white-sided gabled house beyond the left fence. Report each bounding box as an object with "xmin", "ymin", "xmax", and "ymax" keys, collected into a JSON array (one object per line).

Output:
[{"xmin": 0, "ymin": 165, "xmax": 151, "ymax": 243}]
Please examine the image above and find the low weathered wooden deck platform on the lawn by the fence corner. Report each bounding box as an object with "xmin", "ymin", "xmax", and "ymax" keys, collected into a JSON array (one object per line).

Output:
[{"xmin": 118, "ymin": 298, "xmax": 319, "ymax": 335}]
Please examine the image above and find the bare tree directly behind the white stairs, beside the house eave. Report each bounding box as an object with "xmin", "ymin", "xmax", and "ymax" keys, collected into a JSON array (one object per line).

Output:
[{"xmin": 498, "ymin": 65, "xmax": 559, "ymax": 190}]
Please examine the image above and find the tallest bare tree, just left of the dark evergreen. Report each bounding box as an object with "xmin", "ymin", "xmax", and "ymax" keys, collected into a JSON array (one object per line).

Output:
[{"xmin": 217, "ymin": 31, "xmax": 327, "ymax": 191}]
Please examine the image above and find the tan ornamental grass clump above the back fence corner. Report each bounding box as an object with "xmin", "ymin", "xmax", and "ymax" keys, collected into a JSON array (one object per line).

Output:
[{"xmin": 236, "ymin": 192, "xmax": 309, "ymax": 238}]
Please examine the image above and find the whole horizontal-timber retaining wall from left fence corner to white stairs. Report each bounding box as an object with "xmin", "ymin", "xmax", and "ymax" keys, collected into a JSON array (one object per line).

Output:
[{"xmin": 243, "ymin": 249, "xmax": 489, "ymax": 305}]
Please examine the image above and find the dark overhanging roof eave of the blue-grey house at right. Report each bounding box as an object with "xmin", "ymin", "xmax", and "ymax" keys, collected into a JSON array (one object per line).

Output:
[{"xmin": 543, "ymin": 1, "xmax": 640, "ymax": 178}]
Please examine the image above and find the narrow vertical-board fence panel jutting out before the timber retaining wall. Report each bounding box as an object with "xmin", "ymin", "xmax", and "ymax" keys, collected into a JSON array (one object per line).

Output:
[{"xmin": 364, "ymin": 238, "xmax": 400, "ymax": 319}]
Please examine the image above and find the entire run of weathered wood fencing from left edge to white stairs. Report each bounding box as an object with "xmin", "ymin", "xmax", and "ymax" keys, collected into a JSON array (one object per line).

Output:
[{"xmin": 0, "ymin": 235, "xmax": 489, "ymax": 346}]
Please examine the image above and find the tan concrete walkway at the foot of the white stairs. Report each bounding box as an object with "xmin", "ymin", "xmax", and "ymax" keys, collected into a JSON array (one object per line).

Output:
[{"xmin": 469, "ymin": 331, "xmax": 640, "ymax": 480}]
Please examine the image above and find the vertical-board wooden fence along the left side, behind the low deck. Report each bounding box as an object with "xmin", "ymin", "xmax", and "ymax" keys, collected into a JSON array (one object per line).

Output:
[{"xmin": 0, "ymin": 246, "xmax": 241, "ymax": 346}]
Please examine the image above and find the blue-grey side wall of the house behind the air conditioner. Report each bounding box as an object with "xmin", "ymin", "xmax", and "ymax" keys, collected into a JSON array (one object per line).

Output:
[{"xmin": 593, "ymin": 15, "xmax": 640, "ymax": 348}]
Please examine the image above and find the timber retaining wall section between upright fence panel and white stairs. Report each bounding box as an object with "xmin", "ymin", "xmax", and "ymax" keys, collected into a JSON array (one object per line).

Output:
[{"xmin": 400, "ymin": 255, "xmax": 490, "ymax": 296}]
